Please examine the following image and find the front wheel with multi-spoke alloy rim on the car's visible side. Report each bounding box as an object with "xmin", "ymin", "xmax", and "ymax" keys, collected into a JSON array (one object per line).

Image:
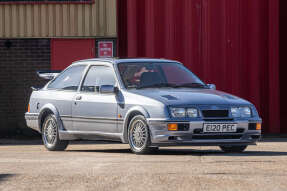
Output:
[{"xmin": 128, "ymin": 115, "xmax": 155, "ymax": 154}]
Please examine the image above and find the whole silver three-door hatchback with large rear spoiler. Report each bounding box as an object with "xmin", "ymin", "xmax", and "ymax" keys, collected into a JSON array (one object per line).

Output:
[{"xmin": 25, "ymin": 59, "xmax": 262, "ymax": 154}]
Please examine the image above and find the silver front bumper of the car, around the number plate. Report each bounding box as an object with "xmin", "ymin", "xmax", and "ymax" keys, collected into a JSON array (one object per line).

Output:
[{"xmin": 148, "ymin": 118, "xmax": 261, "ymax": 146}]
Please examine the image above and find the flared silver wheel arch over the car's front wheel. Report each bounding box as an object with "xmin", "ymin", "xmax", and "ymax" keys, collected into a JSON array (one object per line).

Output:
[{"xmin": 122, "ymin": 106, "xmax": 150, "ymax": 143}]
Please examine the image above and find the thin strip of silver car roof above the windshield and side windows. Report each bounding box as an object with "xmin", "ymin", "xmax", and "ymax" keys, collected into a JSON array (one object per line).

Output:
[{"xmin": 72, "ymin": 58, "xmax": 178, "ymax": 65}]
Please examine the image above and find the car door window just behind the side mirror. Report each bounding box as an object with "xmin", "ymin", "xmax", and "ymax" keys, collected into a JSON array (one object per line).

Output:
[{"xmin": 81, "ymin": 66, "xmax": 116, "ymax": 92}]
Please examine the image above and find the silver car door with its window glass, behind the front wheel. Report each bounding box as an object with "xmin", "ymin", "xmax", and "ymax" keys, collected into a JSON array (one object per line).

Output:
[{"xmin": 72, "ymin": 65, "xmax": 118, "ymax": 133}]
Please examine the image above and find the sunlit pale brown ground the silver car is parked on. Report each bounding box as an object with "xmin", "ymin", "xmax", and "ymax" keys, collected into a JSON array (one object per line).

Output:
[{"xmin": 0, "ymin": 139, "xmax": 287, "ymax": 191}]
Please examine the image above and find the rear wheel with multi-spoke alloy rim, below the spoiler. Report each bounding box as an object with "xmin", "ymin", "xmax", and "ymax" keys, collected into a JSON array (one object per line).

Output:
[{"xmin": 42, "ymin": 114, "xmax": 69, "ymax": 151}]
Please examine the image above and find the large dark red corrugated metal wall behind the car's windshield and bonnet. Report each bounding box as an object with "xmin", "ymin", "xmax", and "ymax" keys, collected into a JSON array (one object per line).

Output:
[{"xmin": 118, "ymin": 0, "xmax": 284, "ymax": 133}]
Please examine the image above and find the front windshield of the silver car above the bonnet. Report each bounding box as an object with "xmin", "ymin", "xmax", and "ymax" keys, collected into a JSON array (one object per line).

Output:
[{"xmin": 118, "ymin": 62, "xmax": 206, "ymax": 89}]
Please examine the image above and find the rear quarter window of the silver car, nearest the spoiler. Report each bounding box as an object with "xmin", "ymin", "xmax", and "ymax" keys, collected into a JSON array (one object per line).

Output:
[{"xmin": 48, "ymin": 65, "xmax": 86, "ymax": 91}]
